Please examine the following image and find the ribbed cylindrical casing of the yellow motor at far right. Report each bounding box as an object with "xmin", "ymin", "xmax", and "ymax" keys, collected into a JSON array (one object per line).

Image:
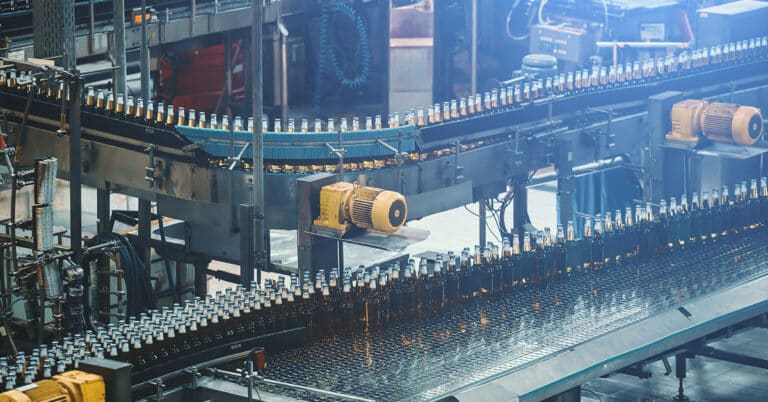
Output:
[{"xmin": 700, "ymin": 103, "xmax": 763, "ymax": 145}]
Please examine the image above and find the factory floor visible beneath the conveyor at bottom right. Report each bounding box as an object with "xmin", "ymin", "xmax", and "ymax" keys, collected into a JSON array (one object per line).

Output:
[{"xmin": 581, "ymin": 328, "xmax": 768, "ymax": 402}]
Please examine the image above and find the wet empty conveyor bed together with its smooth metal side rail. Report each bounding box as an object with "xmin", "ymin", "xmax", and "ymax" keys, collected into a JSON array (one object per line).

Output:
[{"xmin": 265, "ymin": 233, "xmax": 768, "ymax": 401}]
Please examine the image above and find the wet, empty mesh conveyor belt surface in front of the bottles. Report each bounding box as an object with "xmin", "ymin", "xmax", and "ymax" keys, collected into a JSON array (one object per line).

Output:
[{"xmin": 265, "ymin": 231, "xmax": 768, "ymax": 401}]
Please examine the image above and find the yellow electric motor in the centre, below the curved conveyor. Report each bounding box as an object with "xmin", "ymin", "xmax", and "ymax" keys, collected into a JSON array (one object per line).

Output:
[{"xmin": 315, "ymin": 182, "xmax": 408, "ymax": 235}]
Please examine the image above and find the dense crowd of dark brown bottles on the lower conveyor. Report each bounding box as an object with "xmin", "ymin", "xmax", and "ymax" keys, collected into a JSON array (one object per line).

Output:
[{"xmin": 9, "ymin": 178, "xmax": 768, "ymax": 376}]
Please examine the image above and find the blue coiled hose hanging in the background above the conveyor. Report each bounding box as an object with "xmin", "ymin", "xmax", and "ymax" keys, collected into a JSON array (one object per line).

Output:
[{"xmin": 314, "ymin": 3, "xmax": 371, "ymax": 113}]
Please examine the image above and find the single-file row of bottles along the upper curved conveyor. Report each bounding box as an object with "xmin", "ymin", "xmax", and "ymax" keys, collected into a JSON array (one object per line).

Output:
[{"xmin": 0, "ymin": 36, "xmax": 768, "ymax": 133}]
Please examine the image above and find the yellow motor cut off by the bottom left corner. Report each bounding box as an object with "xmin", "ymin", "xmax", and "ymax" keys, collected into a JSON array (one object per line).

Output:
[{"xmin": 0, "ymin": 370, "xmax": 106, "ymax": 402}]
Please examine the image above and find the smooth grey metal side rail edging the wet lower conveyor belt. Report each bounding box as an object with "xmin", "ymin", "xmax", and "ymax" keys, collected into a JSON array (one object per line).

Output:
[{"xmin": 452, "ymin": 276, "xmax": 768, "ymax": 401}]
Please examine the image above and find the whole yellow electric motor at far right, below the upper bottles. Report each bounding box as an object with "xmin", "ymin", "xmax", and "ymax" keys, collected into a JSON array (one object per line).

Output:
[{"xmin": 666, "ymin": 99, "xmax": 763, "ymax": 145}]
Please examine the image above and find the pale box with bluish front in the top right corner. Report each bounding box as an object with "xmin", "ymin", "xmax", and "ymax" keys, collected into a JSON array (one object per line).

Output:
[{"xmin": 696, "ymin": 0, "xmax": 768, "ymax": 48}]
